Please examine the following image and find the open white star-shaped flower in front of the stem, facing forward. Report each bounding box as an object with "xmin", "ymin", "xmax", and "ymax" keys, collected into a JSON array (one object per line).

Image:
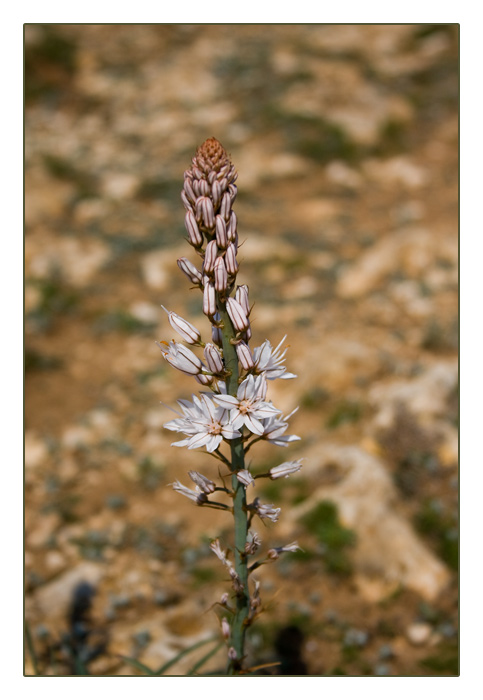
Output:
[{"xmin": 213, "ymin": 374, "xmax": 280, "ymax": 435}]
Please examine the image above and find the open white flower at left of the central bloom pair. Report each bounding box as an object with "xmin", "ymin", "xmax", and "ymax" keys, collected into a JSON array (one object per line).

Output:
[{"xmin": 164, "ymin": 394, "xmax": 241, "ymax": 452}]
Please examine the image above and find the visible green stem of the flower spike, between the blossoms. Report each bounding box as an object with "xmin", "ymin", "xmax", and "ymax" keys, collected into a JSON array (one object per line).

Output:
[{"xmin": 218, "ymin": 300, "xmax": 250, "ymax": 675}]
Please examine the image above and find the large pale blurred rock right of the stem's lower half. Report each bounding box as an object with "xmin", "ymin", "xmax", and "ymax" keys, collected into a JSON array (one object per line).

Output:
[{"xmin": 285, "ymin": 445, "xmax": 450, "ymax": 601}]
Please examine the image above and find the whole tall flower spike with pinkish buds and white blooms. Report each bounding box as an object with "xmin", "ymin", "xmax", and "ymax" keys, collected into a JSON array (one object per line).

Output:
[{"xmin": 158, "ymin": 138, "xmax": 301, "ymax": 668}]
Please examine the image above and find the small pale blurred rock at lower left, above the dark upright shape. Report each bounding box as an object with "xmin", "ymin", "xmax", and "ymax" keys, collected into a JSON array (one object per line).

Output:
[{"xmin": 33, "ymin": 562, "xmax": 104, "ymax": 619}]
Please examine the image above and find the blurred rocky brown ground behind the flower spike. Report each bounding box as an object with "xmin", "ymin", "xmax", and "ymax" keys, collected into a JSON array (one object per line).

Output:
[{"xmin": 25, "ymin": 24, "xmax": 459, "ymax": 676}]
